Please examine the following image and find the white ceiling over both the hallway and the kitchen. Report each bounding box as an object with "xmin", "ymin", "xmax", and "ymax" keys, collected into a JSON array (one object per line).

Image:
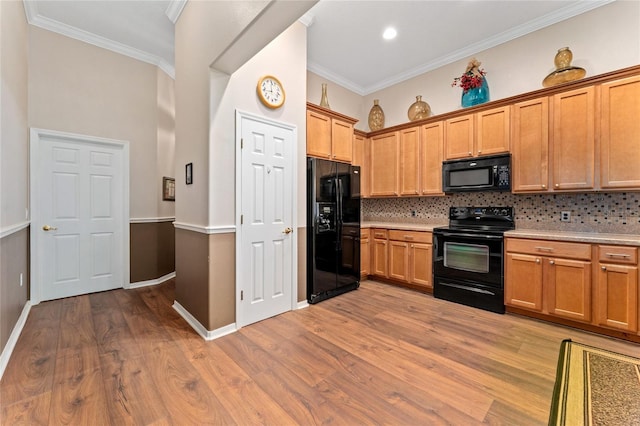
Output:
[{"xmin": 24, "ymin": 0, "xmax": 613, "ymax": 95}]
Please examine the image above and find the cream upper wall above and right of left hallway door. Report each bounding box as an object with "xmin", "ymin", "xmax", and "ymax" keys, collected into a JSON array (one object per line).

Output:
[{"xmin": 29, "ymin": 26, "xmax": 161, "ymax": 218}]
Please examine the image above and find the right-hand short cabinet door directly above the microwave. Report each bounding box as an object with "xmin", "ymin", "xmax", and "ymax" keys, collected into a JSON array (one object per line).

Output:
[{"xmin": 475, "ymin": 106, "xmax": 511, "ymax": 155}]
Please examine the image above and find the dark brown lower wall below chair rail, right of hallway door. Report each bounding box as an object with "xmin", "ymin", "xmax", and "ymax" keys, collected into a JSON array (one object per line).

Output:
[{"xmin": 129, "ymin": 221, "xmax": 175, "ymax": 283}]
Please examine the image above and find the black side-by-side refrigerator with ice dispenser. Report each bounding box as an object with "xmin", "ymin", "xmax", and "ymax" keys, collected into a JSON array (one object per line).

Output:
[{"xmin": 307, "ymin": 157, "xmax": 360, "ymax": 303}]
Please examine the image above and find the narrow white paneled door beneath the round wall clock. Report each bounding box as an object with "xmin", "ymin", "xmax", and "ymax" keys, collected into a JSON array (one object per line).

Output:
[{"xmin": 236, "ymin": 113, "xmax": 296, "ymax": 326}]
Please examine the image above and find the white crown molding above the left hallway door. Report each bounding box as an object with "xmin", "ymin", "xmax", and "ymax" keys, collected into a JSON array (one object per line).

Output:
[{"xmin": 23, "ymin": 0, "xmax": 176, "ymax": 79}]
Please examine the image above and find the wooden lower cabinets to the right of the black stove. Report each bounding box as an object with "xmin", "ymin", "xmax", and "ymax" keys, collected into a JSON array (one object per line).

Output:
[{"xmin": 505, "ymin": 238, "xmax": 640, "ymax": 339}]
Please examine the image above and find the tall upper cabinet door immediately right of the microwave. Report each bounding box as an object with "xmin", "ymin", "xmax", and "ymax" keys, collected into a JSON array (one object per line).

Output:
[{"xmin": 511, "ymin": 96, "xmax": 549, "ymax": 192}]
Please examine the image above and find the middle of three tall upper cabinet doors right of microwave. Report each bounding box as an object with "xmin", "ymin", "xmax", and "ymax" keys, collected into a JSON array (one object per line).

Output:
[{"xmin": 551, "ymin": 87, "xmax": 595, "ymax": 190}]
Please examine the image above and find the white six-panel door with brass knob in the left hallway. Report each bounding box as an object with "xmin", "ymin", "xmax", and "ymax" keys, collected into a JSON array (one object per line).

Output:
[{"xmin": 31, "ymin": 130, "xmax": 129, "ymax": 302}]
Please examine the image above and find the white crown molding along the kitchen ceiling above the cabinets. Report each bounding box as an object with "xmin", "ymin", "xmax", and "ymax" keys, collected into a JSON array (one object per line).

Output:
[{"xmin": 307, "ymin": 0, "xmax": 615, "ymax": 96}]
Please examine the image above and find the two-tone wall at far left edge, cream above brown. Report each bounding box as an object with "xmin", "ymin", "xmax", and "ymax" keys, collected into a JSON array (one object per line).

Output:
[{"xmin": 0, "ymin": 1, "xmax": 29, "ymax": 352}]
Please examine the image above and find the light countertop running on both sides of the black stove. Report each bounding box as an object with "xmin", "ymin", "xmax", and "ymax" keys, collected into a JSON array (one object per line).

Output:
[{"xmin": 360, "ymin": 221, "xmax": 640, "ymax": 247}]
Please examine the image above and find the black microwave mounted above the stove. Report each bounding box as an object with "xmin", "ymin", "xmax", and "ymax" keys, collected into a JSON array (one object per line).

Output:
[{"xmin": 442, "ymin": 154, "xmax": 511, "ymax": 193}]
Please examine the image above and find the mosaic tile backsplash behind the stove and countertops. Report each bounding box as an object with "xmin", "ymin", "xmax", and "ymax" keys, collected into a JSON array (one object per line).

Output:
[{"xmin": 362, "ymin": 192, "xmax": 640, "ymax": 234}]
